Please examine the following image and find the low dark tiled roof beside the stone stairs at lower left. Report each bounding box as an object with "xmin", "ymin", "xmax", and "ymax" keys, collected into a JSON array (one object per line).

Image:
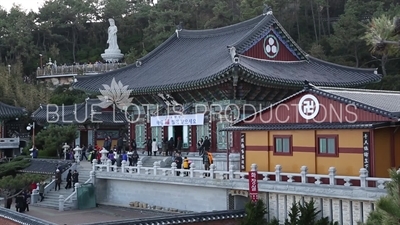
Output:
[{"xmin": 19, "ymin": 157, "xmax": 72, "ymax": 175}]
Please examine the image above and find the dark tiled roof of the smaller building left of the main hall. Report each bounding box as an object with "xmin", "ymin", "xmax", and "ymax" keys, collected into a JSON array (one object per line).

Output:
[{"xmin": 32, "ymin": 99, "xmax": 127, "ymax": 124}]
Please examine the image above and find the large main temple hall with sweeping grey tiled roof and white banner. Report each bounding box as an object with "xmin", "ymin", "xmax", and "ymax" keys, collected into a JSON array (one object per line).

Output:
[{"xmin": 74, "ymin": 10, "xmax": 381, "ymax": 156}]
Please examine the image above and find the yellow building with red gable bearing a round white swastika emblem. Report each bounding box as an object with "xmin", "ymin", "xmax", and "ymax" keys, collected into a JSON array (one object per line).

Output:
[{"xmin": 224, "ymin": 84, "xmax": 400, "ymax": 177}]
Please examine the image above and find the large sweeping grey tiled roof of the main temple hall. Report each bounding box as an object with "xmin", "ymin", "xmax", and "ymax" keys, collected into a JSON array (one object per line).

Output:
[{"xmin": 74, "ymin": 14, "xmax": 381, "ymax": 95}]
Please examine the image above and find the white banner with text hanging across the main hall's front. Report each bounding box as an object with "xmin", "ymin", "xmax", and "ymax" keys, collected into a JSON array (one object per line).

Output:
[{"xmin": 150, "ymin": 113, "xmax": 204, "ymax": 127}]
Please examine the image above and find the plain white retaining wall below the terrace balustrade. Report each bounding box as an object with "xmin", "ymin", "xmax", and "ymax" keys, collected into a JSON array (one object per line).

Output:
[{"xmin": 96, "ymin": 179, "xmax": 228, "ymax": 212}]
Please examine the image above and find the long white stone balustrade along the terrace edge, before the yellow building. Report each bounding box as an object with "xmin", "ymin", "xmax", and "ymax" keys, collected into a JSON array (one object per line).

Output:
[{"xmin": 93, "ymin": 159, "xmax": 390, "ymax": 189}]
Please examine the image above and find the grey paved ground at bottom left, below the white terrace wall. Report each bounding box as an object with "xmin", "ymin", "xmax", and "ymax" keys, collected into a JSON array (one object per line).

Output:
[{"xmin": 25, "ymin": 206, "xmax": 170, "ymax": 225}]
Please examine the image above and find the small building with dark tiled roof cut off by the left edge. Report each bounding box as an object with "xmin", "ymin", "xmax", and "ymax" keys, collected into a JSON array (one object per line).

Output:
[{"xmin": 0, "ymin": 102, "xmax": 26, "ymax": 158}]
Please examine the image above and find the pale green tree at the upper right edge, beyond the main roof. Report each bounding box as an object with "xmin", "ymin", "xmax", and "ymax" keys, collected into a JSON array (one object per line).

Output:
[{"xmin": 363, "ymin": 15, "xmax": 400, "ymax": 76}]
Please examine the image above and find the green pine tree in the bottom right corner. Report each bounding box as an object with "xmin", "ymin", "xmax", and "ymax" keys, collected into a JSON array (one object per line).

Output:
[{"xmin": 367, "ymin": 169, "xmax": 400, "ymax": 225}]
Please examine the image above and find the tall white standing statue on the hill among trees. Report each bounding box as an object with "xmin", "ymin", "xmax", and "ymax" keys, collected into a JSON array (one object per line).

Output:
[{"xmin": 101, "ymin": 19, "xmax": 124, "ymax": 63}]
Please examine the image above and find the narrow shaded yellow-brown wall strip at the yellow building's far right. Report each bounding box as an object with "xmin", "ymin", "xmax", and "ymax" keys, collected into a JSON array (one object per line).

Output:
[{"xmin": 375, "ymin": 129, "xmax": 393, "ymax": 177}]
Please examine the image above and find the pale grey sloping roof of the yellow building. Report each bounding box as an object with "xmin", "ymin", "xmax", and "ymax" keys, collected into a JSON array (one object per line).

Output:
[{"xmin": 310, "ymin": 87, "xmax": 400, "ymax": 118}]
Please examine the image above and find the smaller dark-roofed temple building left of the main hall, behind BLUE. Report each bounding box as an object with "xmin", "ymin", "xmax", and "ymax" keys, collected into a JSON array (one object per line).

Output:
[{"xmin": 31, "ymin": 99, "xmax": 129, "ymax": 147}]
